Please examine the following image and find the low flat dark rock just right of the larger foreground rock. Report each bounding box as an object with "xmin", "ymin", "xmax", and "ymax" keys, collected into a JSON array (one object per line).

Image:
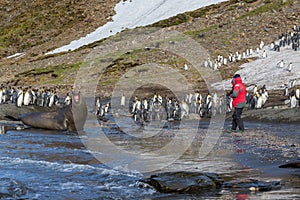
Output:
[{"xmin": 223, "ymin": 179, "xmax": 281, "ymax": 191}]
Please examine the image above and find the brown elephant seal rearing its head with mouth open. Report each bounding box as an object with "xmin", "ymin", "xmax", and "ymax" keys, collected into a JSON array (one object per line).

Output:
[{"xmin": 19, "ymin": 93, "xmax": 87, "ymax": 131}]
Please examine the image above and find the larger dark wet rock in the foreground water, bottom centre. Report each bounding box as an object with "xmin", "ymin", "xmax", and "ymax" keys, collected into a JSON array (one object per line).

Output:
[{"xmin": 141, "ymin": 171, "xmax": 223, "ymax": 194}]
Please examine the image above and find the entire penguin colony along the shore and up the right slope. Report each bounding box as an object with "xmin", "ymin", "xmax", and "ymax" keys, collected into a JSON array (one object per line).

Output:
[{"xmin": 0, "ymin": 26, "xmax": 300, "ymax": 121}]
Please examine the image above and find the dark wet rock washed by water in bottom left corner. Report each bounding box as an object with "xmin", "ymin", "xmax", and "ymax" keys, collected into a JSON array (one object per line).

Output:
[{"xmin": 0, "ymin": 178, "xmax": 27, "ymax": 199}]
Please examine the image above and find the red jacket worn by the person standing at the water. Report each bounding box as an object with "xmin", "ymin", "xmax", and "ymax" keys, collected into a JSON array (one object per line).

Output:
[{"xmin": 231, "ymin": 77, "xmax": 246, "ymax": 108}]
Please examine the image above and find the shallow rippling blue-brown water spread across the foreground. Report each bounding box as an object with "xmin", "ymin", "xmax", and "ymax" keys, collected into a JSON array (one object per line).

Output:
[{"xmin": 0, "ymin": 115, "xmax": 300, "ymax": 199}]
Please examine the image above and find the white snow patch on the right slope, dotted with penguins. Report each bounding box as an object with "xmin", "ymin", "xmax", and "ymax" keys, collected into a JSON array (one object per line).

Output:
[{"xmin": 214, "ymin": 46, "xmax": 300, "ymax": 90}]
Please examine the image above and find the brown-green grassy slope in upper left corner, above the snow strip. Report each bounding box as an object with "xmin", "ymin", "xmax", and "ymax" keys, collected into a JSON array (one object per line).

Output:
[{"xmin": 0, "ymin": 0, "xmax": 118, "ymax": 58}]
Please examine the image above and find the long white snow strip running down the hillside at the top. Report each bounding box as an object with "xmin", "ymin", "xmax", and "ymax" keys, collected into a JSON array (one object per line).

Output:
[{"xmin": 46, "ymin": 0, "xmax": 227, "ymax": 54}]
